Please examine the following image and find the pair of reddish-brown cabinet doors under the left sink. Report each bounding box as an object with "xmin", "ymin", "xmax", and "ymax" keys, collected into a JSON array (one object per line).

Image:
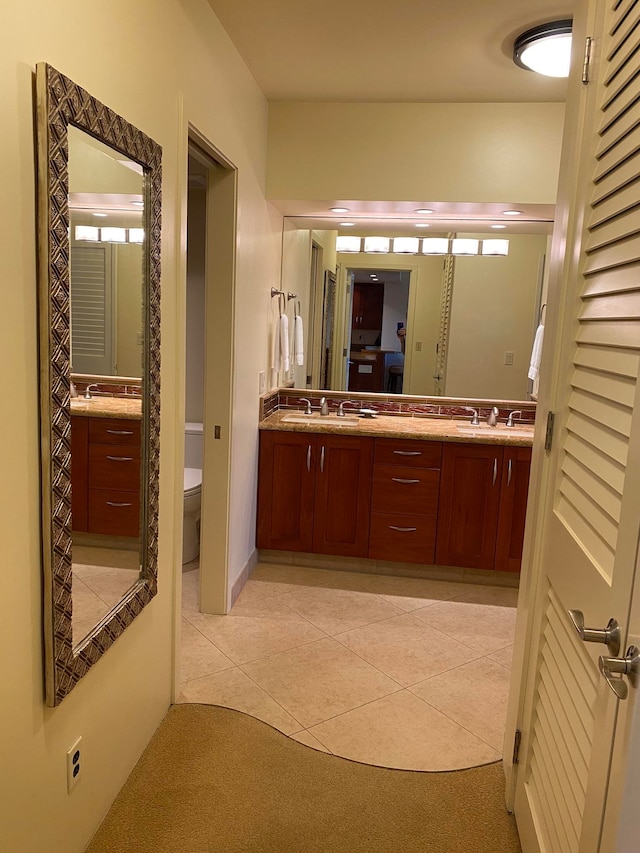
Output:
[{"xmin": 257, "ymin": 430, "xmax": 373, "ymax": 557}]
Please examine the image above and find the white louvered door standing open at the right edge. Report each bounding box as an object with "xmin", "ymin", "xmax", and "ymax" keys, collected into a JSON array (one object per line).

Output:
[{"xmin": 515, "ymin": 0, "xmax": 640, "ymax": 853}]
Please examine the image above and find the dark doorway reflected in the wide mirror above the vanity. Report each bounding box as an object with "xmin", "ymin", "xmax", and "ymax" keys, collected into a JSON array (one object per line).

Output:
[{"xmin": 346, "ymin": 268, "xmax": 411, "ymax": 394}]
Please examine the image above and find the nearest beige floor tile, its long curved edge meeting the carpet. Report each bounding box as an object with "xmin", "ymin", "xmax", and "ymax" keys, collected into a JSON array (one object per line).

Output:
[{"xmin": 311, "ymin": 690, "xmax": 500, "ymax": 770}]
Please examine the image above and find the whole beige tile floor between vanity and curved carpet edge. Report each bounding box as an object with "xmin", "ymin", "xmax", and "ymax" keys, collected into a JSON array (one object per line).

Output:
[{"xmin": 178, "ymin": 563, "xmax": 517, "ymax": 770}]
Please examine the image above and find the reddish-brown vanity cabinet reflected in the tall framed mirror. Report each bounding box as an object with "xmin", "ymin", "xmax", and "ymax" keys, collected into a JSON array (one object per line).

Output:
[{"xmin": 71, "ymin": 416, "xmax": 141, "ymax": 537}]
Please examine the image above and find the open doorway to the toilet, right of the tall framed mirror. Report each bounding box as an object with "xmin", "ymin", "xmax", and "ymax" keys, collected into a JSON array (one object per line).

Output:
[{"xmin": 183, "ymin": 129, "xmax": 237, "ymax": 614}]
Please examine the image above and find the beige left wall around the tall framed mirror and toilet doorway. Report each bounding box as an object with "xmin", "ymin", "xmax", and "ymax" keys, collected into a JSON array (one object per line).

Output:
[{"xmin": 0, "ymin": 0, "xmax": 281, "ymax": 853}]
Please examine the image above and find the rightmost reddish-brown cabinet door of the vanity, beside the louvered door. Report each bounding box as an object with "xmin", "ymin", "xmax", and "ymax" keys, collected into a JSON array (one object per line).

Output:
[{"xmin": 495, "ymin": 447, "xmax": 531, "ymax": 572}]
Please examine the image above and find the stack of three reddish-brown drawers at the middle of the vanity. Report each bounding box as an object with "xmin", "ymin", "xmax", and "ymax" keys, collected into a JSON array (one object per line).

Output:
[{"xmin": 369, "ymin": 439, "xmax": 442, "ymax": 565}]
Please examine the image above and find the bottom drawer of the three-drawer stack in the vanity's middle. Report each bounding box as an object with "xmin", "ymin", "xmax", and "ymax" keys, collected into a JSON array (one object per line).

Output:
[{"xmin": 369, "ymin": 512, "xmax": 436, "ymax": 565}]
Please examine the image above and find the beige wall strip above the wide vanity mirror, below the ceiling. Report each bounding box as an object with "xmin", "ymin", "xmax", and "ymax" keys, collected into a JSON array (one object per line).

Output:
[{"xmin": 267, "ymin": 103, "xmax": 564, "ymax": 204}]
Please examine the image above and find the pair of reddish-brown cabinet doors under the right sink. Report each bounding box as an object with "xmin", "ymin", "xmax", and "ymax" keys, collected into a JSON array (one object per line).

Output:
[{"xmin": 436, "ymin": 443, "xmax": 531, "ymax": 572}]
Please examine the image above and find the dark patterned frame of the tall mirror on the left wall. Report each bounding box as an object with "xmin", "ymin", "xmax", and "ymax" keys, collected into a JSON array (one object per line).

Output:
[{"xmin": 36, "ymin": 63, "xmax": 162, "ymax": 706}]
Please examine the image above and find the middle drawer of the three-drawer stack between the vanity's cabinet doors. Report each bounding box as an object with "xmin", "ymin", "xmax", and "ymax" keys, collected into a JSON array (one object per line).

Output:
[{"xmin": 371, "ymin": 465, "xmax": 440, "ymax": 517}]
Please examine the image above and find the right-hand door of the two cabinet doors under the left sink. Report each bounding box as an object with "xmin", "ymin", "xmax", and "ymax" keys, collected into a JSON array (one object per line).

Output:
[{"xmin": 313, "ymin": 435, "xmax": 373, "ymax": 557}]
